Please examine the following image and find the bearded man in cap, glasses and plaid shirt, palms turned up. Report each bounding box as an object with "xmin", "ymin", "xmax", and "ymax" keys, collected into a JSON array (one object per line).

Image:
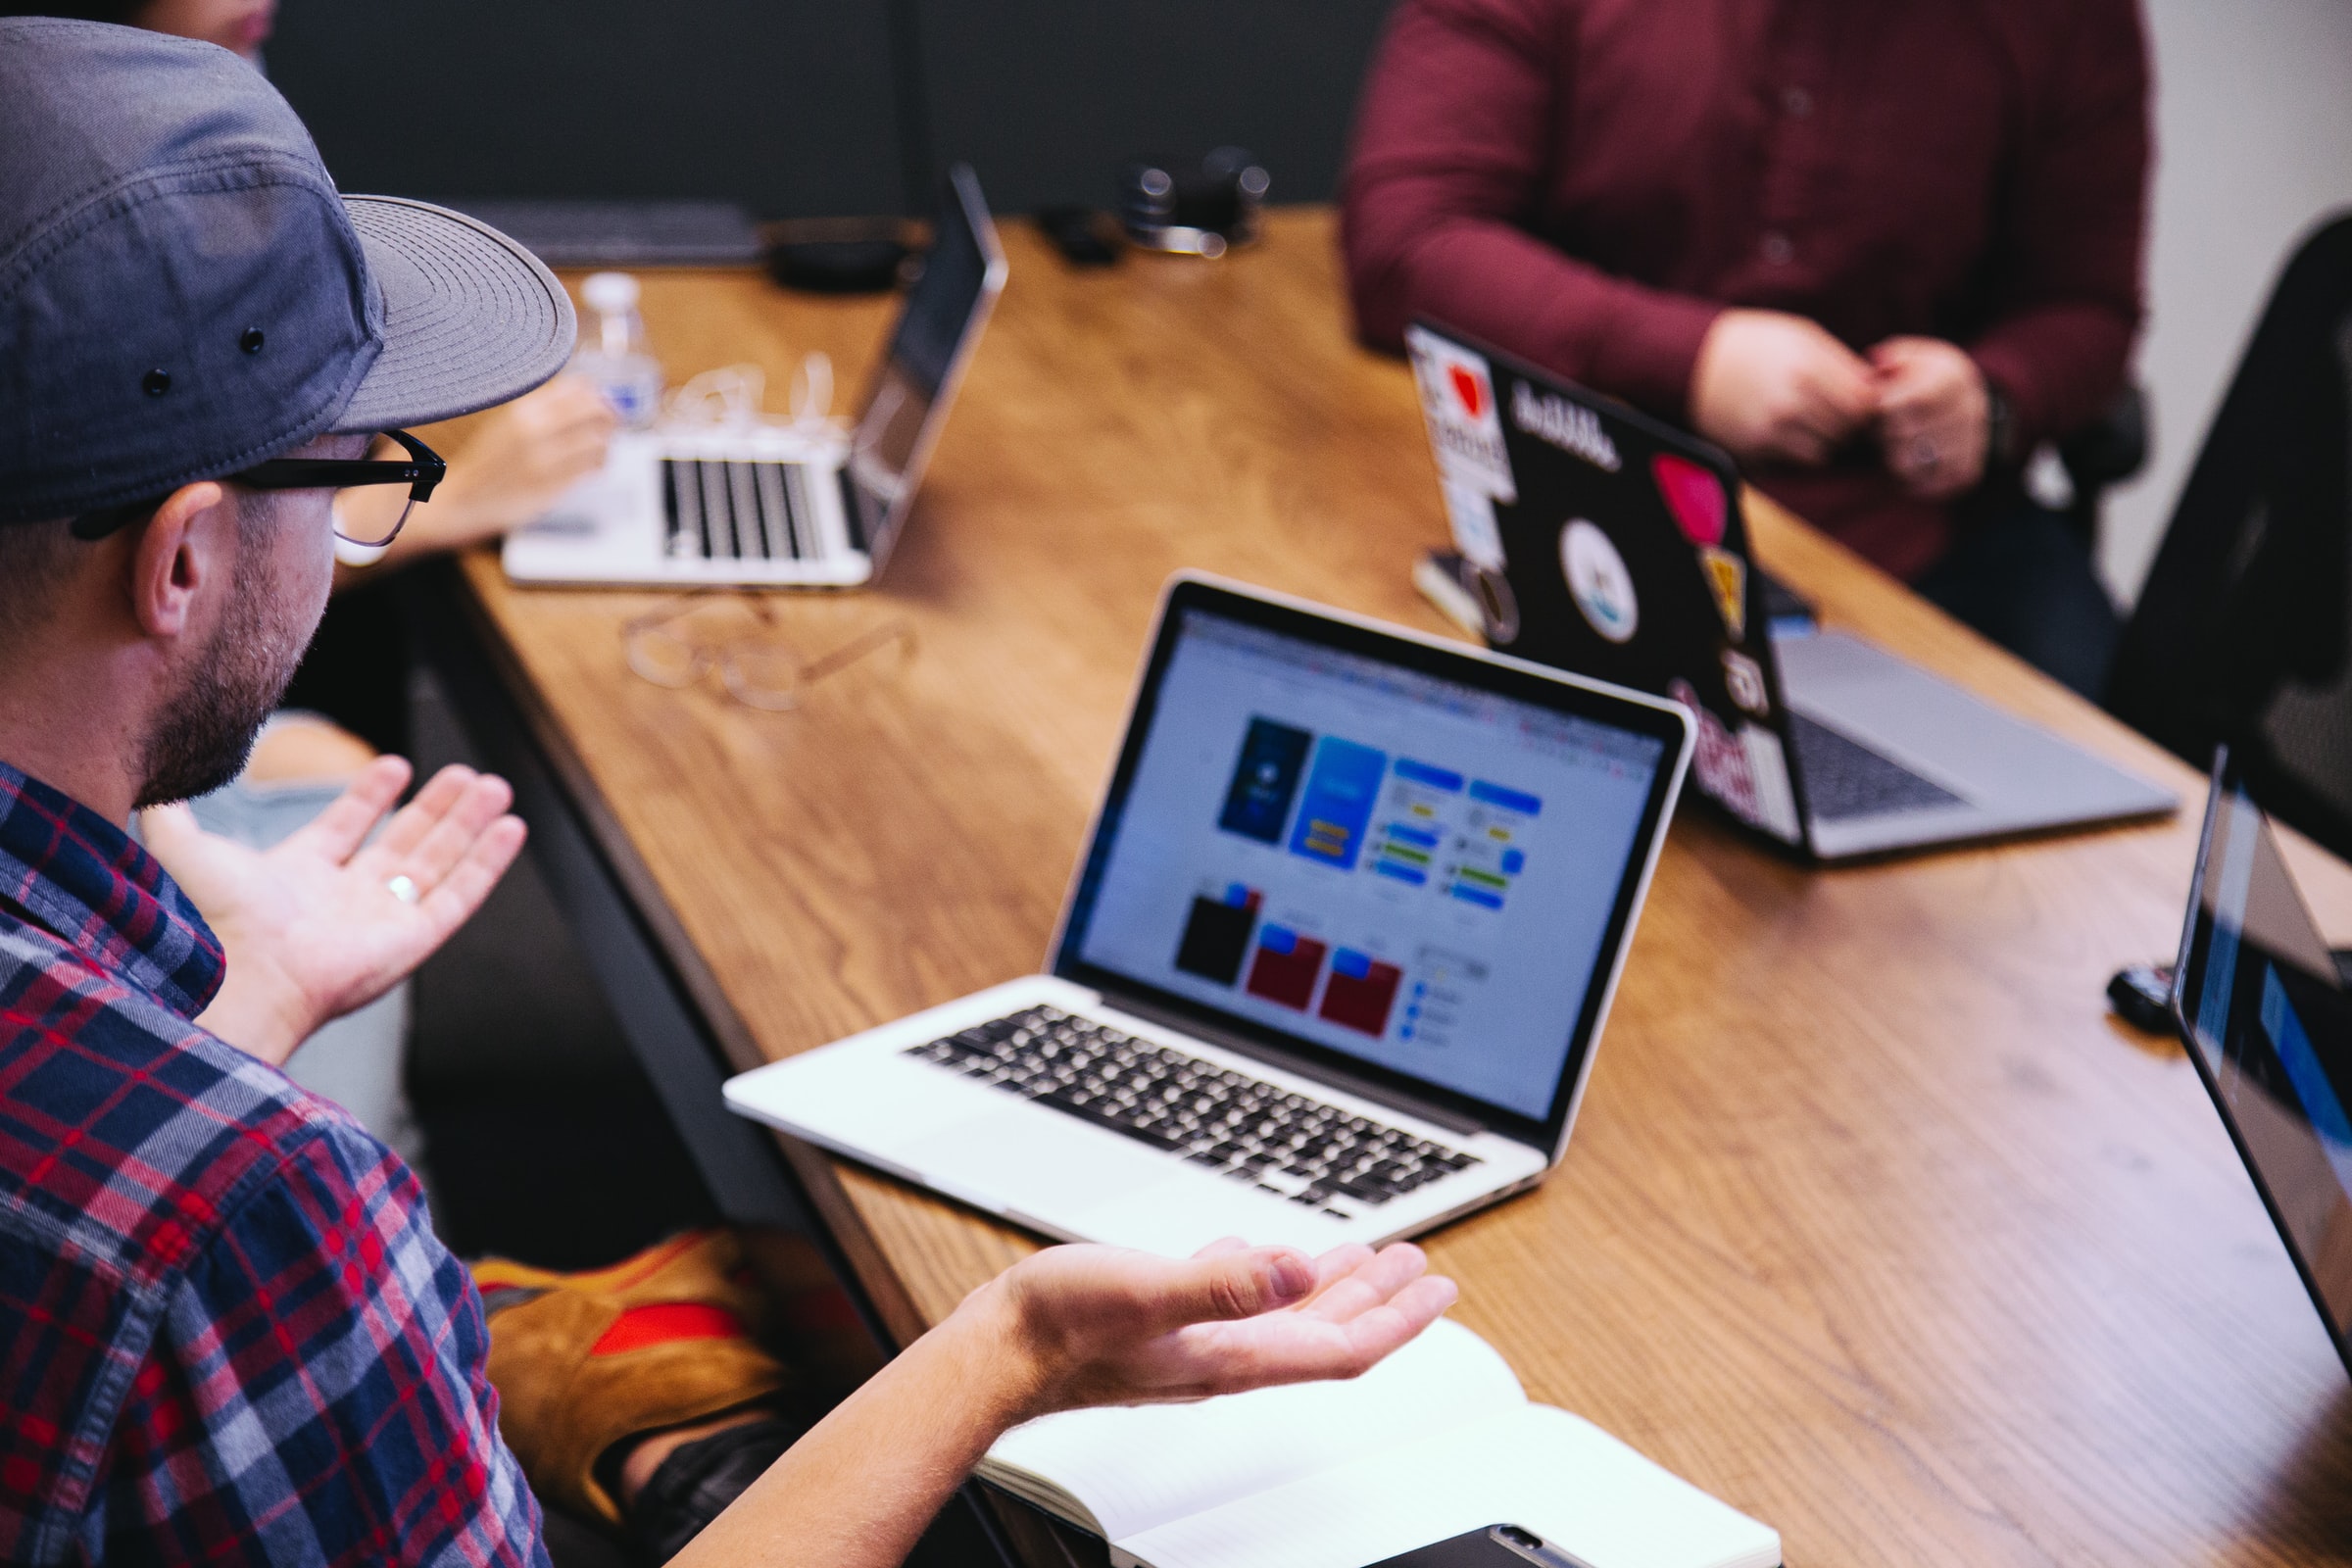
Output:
[{"xmin": 0, "ymin": 19, "xmax": 1453, "ymax": 1566}]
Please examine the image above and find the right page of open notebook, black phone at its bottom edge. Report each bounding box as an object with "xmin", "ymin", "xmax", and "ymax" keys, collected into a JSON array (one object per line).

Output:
[{"xmin": 1112, "ymin": 1403, "xmax": 1781, "ymax": 1568}]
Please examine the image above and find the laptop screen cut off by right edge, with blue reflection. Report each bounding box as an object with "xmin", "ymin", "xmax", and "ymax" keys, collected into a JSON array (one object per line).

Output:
[{"xmin": 2174, "ymin": 750, "xmax": 2352, "ymax": 1368}]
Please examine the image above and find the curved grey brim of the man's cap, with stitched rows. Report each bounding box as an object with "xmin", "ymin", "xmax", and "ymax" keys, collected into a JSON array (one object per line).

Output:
[{"xmin": 334, "ymin": 195, "xmax": 576, "ymax": 432}]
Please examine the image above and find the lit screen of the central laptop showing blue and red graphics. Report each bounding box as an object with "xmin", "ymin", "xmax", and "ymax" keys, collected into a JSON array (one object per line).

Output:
[{"xmin": 1054, "ymin": 578, "xmax": 1691, "ymax": 1150}]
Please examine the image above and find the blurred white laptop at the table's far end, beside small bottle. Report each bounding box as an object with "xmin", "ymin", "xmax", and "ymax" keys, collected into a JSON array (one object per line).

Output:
[{"xmin": 504, "ymin": 165, "xmax": 1004, "ymax": 588}]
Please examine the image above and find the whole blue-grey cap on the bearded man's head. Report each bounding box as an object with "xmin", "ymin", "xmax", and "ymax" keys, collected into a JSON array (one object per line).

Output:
[{"xmin": 0, "ymin": 17, "xmax": 574, "ymax": 522}]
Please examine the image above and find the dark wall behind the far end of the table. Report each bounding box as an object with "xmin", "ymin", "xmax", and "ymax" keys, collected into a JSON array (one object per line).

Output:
[{"xmin": 269, "ymin": 0, "xmax": 1390, "ymax": 217}]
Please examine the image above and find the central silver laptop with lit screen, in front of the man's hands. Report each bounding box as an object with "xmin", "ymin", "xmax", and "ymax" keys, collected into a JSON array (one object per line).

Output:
[{"xmin": 727, "ymin": 576, "xmax": 1691, "ymax": 1255}]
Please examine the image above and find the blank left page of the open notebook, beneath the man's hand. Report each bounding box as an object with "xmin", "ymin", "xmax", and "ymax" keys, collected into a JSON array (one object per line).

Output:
[{"xmin": 988, "ymin": 1319, "xmax": 1527, "ymax": 1542}]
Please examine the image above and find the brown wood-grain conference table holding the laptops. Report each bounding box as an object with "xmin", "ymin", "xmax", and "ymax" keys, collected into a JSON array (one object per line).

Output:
[{"xmin": 432, "ymin": 212, "xmax": 2352, "ymax": 1568}]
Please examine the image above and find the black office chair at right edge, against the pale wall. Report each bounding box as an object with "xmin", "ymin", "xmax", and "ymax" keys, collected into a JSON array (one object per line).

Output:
[{"xmin": 2107, "ymin": 214, "xmax": 2352, "ymax": 856}]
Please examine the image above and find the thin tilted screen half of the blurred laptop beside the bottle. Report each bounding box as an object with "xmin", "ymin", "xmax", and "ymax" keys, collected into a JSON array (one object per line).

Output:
[{"xmin": 842, "ymin": 165, "xmax": 1006, "ymax": 576}]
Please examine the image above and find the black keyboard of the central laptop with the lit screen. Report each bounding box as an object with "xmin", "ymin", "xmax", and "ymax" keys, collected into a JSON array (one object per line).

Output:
[{"xmin": 906, "ymin": 1006, "xmax": 1480, "ymax": 1220}]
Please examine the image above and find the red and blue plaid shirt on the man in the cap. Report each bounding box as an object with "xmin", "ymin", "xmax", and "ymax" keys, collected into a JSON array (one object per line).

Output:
[{"xmin": 0, "ymin": 764, "xmax": 546, "ymax": 1563}]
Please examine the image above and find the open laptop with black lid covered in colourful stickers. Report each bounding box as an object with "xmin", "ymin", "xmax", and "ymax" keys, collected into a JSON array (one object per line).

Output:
[{"xmin": 1406, "ymin": 322, "xmax": 2176, "ymax": 860}]
